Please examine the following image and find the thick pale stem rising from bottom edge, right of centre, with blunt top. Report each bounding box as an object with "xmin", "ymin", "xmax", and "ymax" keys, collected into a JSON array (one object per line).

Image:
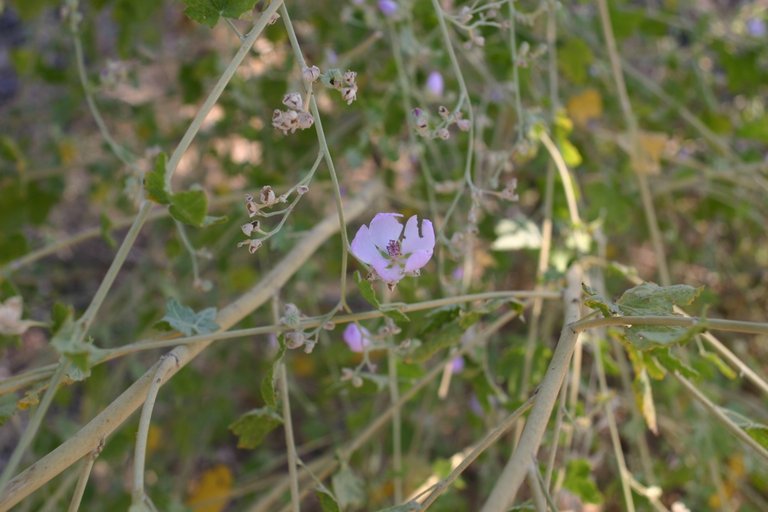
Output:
[{"xmin": 482, "ymin": 265, "xmax": 582, "ymax": 512}]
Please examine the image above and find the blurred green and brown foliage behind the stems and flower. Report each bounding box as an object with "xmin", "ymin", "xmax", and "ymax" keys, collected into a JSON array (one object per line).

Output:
[{"xmin": 0, "ymin": 0, "xmax": 768, "ymax": 512}]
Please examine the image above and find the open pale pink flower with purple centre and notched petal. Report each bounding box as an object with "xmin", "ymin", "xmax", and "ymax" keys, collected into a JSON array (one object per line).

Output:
[{"xmin": 350, "ymin": 213, "xmax": 435, "ymax": 287}]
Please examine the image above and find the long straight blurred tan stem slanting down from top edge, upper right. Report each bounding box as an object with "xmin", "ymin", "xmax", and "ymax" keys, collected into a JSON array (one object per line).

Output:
[{"xmin": 597, "ymin": 0, "xmax": 672, "ymax": 286}]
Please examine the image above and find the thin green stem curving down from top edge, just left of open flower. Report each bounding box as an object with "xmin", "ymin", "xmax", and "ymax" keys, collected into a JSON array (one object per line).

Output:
[{"xmin": 280, "ymin": 2, "xmax": 349, "ymax": 306}]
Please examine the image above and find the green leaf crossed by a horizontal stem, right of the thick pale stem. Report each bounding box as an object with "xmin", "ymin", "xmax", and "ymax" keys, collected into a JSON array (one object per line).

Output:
[{"xmin": 616, "ymin": 283, "xmax": 704, "ymax": 350}]
